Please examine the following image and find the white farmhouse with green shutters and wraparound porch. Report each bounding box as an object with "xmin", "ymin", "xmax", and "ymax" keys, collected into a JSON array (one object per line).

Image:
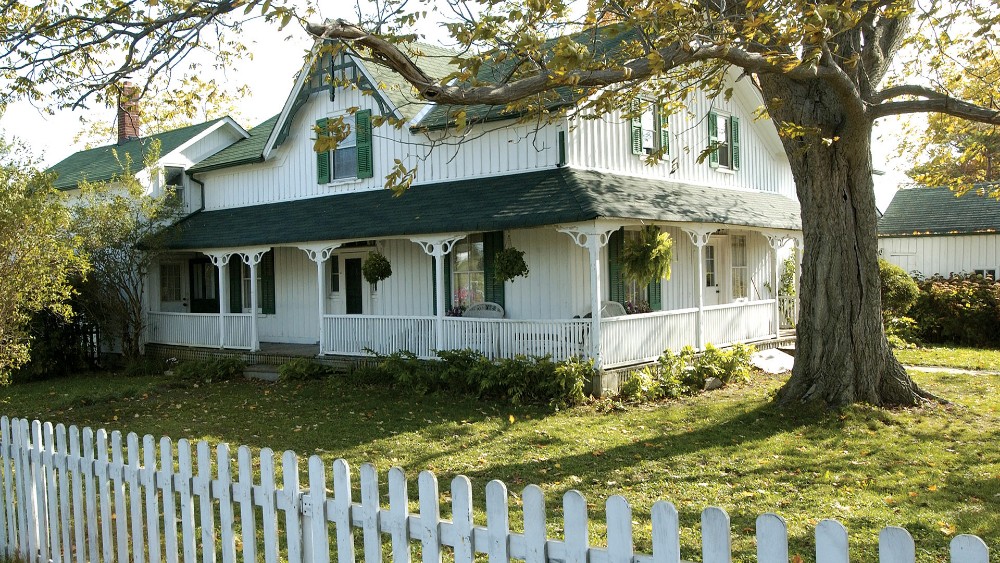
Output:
[{"xmin": 48, "ymin": 33, "xmax": 801, "ymax": 369}]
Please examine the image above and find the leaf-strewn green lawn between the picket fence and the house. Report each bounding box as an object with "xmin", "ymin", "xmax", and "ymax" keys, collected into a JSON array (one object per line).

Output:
[{"xmin": 0, "ymin": 374, "xmax": 1000, "ymax": 561}]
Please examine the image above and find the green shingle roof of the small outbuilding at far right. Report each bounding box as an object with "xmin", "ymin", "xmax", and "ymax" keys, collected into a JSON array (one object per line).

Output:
[{"xmin": 878, "ymin": 188, "xmax": 1000, "ymax": 237}]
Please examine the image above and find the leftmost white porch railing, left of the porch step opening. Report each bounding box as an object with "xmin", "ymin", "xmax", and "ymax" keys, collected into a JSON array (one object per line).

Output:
[{"xmin": 147, "ymin": 311, "xmax": 253, "ymax": 350}]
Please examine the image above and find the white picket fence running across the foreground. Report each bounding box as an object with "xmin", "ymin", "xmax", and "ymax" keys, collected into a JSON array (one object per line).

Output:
[{"xmin": 0, "ymin": 417, "xmax": 989, "ymax": 563}]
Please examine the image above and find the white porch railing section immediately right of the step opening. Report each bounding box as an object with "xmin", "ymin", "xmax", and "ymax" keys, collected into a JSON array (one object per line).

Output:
[{"xmin": 323, "ymin": 315, "xmax": 435, "ymax": 358}]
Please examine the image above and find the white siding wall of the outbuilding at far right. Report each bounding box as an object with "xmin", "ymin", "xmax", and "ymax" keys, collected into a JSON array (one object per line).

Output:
[{"xmin": 878, "ymin": 235, "xmax": 1000, "ymax": 277}]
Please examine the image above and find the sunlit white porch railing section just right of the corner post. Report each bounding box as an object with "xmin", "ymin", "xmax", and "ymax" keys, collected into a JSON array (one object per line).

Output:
[{"xmin": 601, "ymin": 309, "xmax": 698, "ymax": 368}]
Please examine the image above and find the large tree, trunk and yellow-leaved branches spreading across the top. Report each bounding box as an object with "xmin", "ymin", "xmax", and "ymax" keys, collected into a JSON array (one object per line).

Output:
[{"xmin": 0, "ymin": 0, "xmax": 1000, "ymax": 405}]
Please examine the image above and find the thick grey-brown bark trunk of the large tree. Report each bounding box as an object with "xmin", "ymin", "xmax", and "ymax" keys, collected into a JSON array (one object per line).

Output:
[{"xmin": 761, "ymin": 76, "xmax": 927, "ymax": 406}]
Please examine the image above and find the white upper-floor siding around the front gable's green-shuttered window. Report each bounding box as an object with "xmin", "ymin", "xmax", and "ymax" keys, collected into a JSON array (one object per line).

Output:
[{"xmin": 199, "ymin": 89, "xmax": 559, "ymax": 210}]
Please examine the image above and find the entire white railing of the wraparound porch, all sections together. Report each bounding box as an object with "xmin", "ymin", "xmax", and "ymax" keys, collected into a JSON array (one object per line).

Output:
[{"xmin": 149, "ymin": 299, "xmax": 782, "ymax": 369}]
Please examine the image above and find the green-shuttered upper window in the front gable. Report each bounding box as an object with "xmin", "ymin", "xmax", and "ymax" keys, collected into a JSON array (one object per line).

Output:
[{"xmin": 316, "ymin": 110, "xmax": 374, "ymax": 184}]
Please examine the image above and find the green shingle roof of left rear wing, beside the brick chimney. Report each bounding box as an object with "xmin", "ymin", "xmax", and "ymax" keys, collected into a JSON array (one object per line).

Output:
[{"xmin": 48, "ymin": 117, "xmax": 226, "ymax": 190}]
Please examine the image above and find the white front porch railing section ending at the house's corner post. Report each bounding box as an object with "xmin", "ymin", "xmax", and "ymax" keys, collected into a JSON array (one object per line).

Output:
[{"xmin": 442, "ymin": 317, "xmax": 590, "ymax": 361}]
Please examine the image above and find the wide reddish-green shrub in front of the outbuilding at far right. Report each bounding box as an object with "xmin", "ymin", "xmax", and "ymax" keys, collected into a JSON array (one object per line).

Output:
[{"xmin": 910, "ymin": 274, "xmax": 1000, "ymax": 347}]
